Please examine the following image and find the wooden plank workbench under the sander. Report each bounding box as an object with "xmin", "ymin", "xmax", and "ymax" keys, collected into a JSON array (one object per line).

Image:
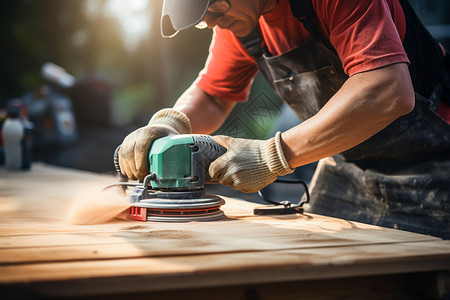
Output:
[{"xmin": 0, "ymin": 163, "xmax": 450, "ymax": 299}]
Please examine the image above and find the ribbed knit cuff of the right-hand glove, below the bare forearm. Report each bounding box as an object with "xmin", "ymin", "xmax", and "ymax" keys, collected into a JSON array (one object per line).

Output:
[{"xmin": 263, "ymin": 131, "xmax": 294, "ymax": 176}]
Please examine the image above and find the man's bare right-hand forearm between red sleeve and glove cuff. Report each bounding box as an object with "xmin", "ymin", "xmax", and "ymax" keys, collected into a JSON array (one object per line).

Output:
[{"xmin": 282, "ymin": 63, "xmax": 415, "ymax": 168}]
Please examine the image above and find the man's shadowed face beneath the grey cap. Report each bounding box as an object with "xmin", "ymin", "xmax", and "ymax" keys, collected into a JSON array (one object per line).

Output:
[{"xmin": 204, "ymin": 0, "xmax": 270, "ymax": 37}]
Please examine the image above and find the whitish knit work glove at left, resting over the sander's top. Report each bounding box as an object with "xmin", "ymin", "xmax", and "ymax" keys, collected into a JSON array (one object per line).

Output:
[{"xmin": 119, "ymin": 108, "xmax": 192, "ymax": 180}]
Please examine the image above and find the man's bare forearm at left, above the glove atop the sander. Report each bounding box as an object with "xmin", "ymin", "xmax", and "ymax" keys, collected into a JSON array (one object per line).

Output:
[{"xmin": 173, "ymin": 84, "xmax": 235, "ymax": 134}]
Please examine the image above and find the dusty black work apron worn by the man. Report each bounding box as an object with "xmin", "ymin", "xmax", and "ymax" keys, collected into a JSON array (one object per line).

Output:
[{"xmin": 241, "ymin": 0, "xmax": 450, "ymax": 238}]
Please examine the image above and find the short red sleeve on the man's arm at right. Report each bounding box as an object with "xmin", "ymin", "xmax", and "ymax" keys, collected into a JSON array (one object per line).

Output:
[{"xmin": 314, "ymin": 0, "xmax": 409, "ymax": 76}]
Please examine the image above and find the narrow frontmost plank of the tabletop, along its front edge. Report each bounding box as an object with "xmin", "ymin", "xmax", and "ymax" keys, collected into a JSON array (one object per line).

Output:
[{"xmin": 0, "ymin": 233, "xmax": 436, "ymax": 265}]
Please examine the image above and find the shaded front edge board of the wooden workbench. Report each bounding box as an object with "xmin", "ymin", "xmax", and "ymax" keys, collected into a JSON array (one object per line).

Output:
[{"xmin": 0, "ymin": 241, "xmax": 450, "ymax": 290}]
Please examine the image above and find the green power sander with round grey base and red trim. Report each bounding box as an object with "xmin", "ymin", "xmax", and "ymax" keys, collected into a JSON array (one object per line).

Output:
[{"xmin": 128, "ymin": 134, "xmax": 226, "ymax": 222}]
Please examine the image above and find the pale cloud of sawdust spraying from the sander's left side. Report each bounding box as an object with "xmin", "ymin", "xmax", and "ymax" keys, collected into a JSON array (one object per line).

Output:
[{"xmin": 67, "ymin": 188, "xmax": 130, "ymax": 225}]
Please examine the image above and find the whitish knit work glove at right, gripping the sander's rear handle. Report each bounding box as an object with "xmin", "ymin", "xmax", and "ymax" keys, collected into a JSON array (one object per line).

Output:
[{"xmin": 209, "ymin": 132, "xmax": 294, "ymax": 193}]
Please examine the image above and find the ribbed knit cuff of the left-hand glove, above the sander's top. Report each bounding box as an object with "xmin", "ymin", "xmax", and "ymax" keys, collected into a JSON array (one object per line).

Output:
[{"xmin": 148, "ymin": 108, "xmax": 192, "ymax": 134}]
